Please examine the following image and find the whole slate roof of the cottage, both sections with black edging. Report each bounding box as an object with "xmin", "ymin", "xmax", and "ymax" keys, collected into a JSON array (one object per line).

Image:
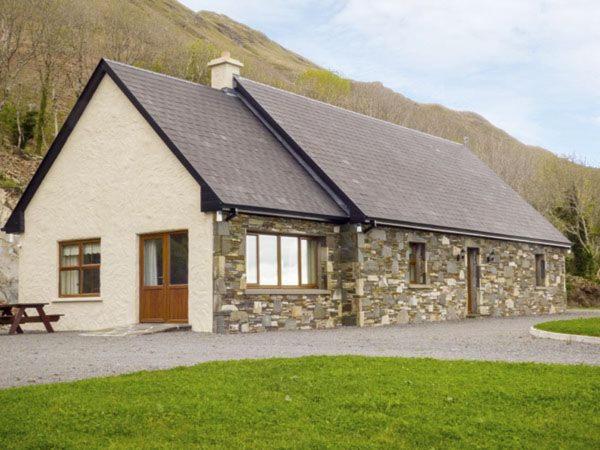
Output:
[{"xmin": 3, "ymin": 60, "xmax": 570, "ymax": 246}]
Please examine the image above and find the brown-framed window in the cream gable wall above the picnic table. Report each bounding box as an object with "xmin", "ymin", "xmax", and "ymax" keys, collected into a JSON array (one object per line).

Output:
[{"xmin": 58, "ymin": 239, "xmax": 100, "ymax": 297}]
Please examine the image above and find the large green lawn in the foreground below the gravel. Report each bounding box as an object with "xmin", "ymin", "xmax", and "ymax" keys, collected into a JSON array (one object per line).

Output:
[{"xmin": 0, "ymin": 355, "xmax": 600, "ymax": 449}]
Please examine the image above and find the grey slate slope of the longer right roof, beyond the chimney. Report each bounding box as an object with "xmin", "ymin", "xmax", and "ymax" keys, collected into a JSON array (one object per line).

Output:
[{"xmin": 237, "ymin": 77, "xmax": 569, "ymax": 244}]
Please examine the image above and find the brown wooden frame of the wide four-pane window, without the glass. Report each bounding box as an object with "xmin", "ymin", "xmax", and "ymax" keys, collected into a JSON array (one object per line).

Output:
[{"xmin": 245, "ymin": 231, "xmax": 320, "ymax": 289}]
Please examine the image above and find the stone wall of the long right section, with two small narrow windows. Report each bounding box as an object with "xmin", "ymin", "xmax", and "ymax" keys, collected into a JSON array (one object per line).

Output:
[{"xmin": 356, "ymin": 227, "xmax": 566, "ymax": 326}]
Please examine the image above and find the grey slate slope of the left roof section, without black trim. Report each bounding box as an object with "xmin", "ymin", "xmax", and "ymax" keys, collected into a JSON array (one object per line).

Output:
[{"xmin": 106, "ymin": 61, "xmax": 346, "ymax": 217}]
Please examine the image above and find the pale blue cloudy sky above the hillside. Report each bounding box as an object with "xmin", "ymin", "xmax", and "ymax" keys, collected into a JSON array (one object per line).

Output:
[{"xmin": 180, "ymin": 0, "xmax": 600, "ymax": 167}]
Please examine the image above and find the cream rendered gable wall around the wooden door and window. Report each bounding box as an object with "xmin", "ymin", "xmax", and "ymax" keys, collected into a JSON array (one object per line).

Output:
[{"xmin": 19, "ymin": 75, "xmax": 213, "ymax": 331}]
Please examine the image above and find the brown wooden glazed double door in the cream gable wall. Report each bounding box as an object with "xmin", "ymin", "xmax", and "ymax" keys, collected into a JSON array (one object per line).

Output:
[{"xmin": 140, "ymin": 231, "xmax": 188, "ymax": 323}]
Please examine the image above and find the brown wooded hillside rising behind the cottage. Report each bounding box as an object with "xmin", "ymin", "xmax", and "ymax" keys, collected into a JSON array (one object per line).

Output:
[{"xmin": 0, "ymin": 0, "xmax": 600, "ymax": 275}]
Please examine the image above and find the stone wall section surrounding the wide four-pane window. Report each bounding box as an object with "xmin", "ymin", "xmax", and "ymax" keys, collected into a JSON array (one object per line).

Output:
[{"xmin": 213, "ymin": 215, "xmax": 341, "ymax": 333}]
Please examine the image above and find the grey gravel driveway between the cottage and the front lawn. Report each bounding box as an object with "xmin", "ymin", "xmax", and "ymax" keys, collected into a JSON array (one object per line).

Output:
[{"xmin": 0, "ymin": 311, "xmax": 600, "ymax": 387}]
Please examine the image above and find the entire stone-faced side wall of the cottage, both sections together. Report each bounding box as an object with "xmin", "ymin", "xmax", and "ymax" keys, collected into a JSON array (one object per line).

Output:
[{"xmin": 213, "ymin": 215, "xmax": 566, "ymax": 333}]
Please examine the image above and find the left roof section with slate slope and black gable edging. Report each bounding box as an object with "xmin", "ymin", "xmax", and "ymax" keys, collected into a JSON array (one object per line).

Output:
[{"xmin": 3, "ymin": 60, "xmax": 347, "ymax": 233}]
